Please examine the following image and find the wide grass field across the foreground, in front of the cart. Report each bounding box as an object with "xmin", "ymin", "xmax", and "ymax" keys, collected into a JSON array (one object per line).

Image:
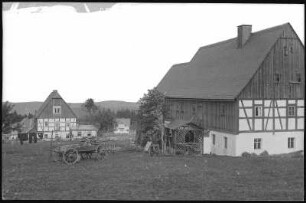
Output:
[{"xmin": 2, "ymin": 142, "xmax": 304, "ymax": 200}]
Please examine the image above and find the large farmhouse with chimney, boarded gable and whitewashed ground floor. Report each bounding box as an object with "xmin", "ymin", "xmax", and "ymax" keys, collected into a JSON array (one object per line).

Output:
[{"xmin": 157, "ymin": 23, "xmax": 305, "ymax": 156}]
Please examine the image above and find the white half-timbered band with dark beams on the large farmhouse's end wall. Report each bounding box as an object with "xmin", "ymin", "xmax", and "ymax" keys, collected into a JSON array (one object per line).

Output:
[{"xmin": 239, "ymin": 99, "xmax": 304, "ymax": 132}]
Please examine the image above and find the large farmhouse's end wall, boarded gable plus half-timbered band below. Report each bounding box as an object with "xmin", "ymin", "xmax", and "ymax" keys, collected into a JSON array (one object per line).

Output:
[{"xmin": 238, "ymin": 25, "xmax": 305, "ymax": 132}]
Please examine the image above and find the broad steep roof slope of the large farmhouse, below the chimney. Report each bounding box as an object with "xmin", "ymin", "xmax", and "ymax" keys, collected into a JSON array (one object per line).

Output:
[{"xmin": 157, "ymin": 23, "xmax": 292, "ymax": 100}]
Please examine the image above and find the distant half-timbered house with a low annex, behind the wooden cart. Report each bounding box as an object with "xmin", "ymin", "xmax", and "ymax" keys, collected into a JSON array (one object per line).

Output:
[{"xmin": 35, "ymin": 90, "xmax": 97, "ymax": 140}]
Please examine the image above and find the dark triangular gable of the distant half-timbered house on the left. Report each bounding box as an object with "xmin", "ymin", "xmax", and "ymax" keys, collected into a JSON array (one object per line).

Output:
[{"xmin": 36, "ymin": 91, "xmax": 77, "ymax": 118}]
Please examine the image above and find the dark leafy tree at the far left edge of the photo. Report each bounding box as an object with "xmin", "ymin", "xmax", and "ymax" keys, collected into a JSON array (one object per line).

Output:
[{"xmin": 2, "ymin": 101, "xmax": 26, "ymax": 134}]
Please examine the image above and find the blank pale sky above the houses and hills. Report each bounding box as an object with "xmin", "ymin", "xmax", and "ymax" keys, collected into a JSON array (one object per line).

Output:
[{"xmin": 2, "ymin": 3, "xmax": 305, "ymax": 103}]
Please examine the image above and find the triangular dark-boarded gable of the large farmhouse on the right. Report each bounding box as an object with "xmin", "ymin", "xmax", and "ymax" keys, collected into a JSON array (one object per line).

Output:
[{"xmin": 238, "ymin": 25, "xmax": 305, "ymax": 99}]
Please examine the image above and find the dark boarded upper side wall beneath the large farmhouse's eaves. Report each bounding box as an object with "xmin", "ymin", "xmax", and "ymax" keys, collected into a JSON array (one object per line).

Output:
[{"xmin": 167, "ymin": 99, "xmax": 238, "ymax": 133}]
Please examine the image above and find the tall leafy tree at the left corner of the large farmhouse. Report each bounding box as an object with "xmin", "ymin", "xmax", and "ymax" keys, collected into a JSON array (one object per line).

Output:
[{"xmin": 137, "ymin": 87, "xmax": 168, "ymax": 151}]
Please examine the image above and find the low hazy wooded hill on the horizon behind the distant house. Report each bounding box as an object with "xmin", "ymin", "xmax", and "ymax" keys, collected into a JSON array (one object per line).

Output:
[{"xmin": 7, "ymin": 101, "xmax": 138, "ymax": 117}]
